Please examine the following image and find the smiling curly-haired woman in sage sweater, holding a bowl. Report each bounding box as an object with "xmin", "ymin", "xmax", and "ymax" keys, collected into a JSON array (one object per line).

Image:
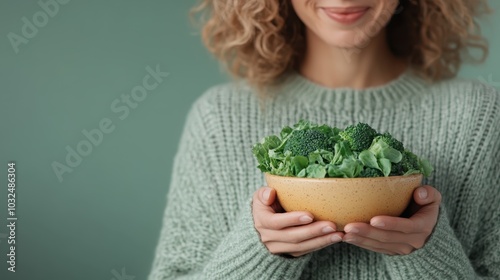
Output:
[{"xmin": 150, "ymin": 0, "xmax": 500, "ymax": 279}]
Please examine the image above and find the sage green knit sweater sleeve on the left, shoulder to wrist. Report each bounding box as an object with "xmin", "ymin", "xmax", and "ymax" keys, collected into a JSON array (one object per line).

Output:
[{"xmin": 148, "ymin": 92, "xmax": 310, "ymax": 280}]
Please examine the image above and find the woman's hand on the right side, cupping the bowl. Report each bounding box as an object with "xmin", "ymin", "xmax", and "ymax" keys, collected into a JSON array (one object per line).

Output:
[{"xmin": 343, "ymin": 186, "xmax": 441, "ymax": 255}]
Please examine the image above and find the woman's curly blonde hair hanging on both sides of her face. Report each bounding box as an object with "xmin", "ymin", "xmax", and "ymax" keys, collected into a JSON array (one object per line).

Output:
[{"xmin": 192, "ymin": 0, "xmax": 489, "ymax": 91}]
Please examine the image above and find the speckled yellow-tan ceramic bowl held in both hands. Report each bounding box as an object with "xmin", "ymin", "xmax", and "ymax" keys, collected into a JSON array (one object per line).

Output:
[{"xmin": 265, "ymin": 173, "xmax": 423, "ymax": 231}]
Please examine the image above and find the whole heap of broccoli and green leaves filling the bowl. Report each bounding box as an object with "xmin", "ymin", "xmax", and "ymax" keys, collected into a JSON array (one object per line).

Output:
[{"xmin": 252, "ymin": 120, "xmax": 433, "ymax": 178}]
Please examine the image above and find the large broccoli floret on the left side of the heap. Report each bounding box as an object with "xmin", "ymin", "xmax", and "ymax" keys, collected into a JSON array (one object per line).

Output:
[{"xmin": 284, "ymin": 129, "xmax": 333, "ymax": 156}]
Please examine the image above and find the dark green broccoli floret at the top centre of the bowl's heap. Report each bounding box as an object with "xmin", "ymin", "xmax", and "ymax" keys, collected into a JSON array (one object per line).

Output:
[{"xmin": 339, "ymin": 123, "xmax": 378, "ymax": 152}]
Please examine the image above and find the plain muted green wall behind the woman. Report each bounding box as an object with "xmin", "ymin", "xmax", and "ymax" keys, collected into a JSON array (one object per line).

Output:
[{"xmin": 0, "ymin": 0, "xmax": 500, "ymax": 280}]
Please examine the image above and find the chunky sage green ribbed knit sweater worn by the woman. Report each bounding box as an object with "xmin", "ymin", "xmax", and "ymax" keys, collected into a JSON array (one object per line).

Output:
[{"xmin": 149, "ymin": 71, "xmax": 500, "ymax": 280}]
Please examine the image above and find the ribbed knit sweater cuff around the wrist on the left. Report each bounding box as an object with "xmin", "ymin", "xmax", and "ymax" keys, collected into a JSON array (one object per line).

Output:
[{"xmin": 205, "ymin": 198, "xmax": 311, "ymax": 280}]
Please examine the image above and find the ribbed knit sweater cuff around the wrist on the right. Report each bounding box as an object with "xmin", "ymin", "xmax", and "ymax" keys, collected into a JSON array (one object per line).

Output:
[{"xmin": 384, "ymin": 205, "xmax": 475, "ymax": 279}]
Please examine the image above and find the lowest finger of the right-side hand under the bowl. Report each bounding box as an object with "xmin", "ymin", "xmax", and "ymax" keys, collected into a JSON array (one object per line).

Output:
[{"xmin": 343, "ymin": 233, "xmax": 415, "ymax": 255}]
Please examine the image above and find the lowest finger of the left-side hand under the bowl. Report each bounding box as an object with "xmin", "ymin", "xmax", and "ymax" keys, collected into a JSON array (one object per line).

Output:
[{"xmin": 266, "ymin": 232, "xmax": 342, "ymax": 257}]
